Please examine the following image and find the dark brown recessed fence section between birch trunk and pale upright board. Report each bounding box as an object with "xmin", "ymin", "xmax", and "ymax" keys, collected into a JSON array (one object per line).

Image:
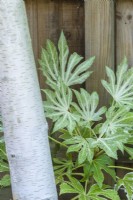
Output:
[{"xmin": 25, "ymin": 0, "xmax": 84, "ymax": 88}]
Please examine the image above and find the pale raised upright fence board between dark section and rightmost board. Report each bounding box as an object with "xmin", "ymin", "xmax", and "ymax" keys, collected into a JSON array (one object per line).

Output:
[{"xmin": 85, "ymin": 0, "xmax": 114, "ymax": 105}]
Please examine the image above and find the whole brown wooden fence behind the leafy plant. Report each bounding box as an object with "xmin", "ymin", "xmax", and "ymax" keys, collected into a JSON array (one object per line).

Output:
[{"xmin": 25, "ymin": 0, "xmax": 133, "ymax": 198}]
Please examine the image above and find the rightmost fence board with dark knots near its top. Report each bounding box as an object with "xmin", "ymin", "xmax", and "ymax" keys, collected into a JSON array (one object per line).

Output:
[{"xmin": 116, "ymin": 0, "xmax": 133, "ymax": 66}]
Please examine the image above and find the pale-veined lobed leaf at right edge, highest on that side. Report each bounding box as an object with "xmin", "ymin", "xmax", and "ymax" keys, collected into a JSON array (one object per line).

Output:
[{"xmin": 102, "ymin": 58, "xmax": 133, "ymax": 107}]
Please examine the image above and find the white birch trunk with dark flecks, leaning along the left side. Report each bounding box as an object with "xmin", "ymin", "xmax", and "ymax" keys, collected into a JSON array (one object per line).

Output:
[{"xmin": 0, "ymin": 0, "xmax": 57, "ymax": 200}]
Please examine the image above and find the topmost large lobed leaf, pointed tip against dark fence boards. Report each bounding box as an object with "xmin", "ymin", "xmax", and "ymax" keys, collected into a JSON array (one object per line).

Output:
[{"xmin": 39, "ymin": 32, "xmax": 94, "ymax": 90}]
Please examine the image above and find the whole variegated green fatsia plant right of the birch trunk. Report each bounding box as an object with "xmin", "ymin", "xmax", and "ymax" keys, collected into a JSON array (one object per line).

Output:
[{"xmin": 39, "ymin": 32, "xmax": 133, "ymax": 200}]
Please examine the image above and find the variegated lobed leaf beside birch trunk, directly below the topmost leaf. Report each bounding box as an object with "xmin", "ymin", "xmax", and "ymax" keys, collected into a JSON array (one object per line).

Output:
[{"xmin": 43, "ymin": 83, "xmax": 79, "ymax": 132}]
